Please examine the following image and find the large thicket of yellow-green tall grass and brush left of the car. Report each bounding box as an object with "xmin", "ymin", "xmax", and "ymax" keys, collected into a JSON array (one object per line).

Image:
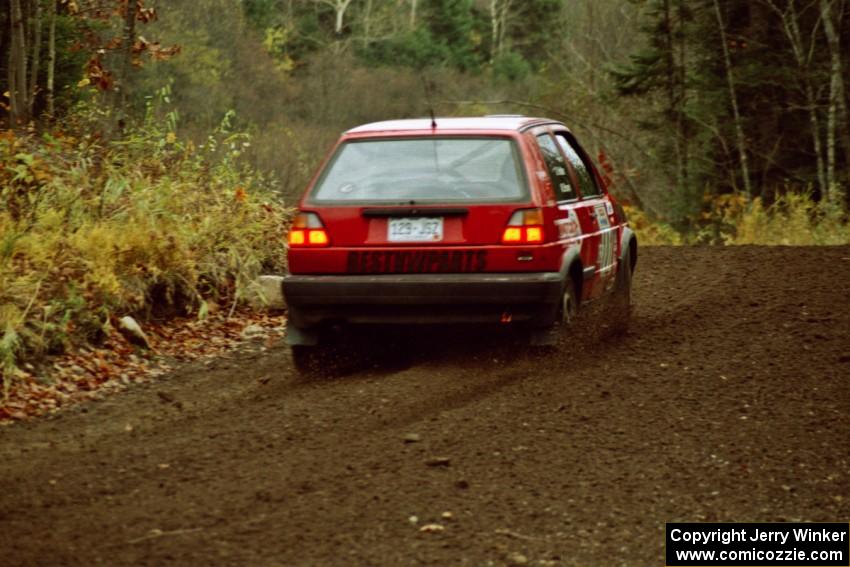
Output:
[{"xmin": 0, "ymin": 103, "xmax": 289, "ymax": 394}]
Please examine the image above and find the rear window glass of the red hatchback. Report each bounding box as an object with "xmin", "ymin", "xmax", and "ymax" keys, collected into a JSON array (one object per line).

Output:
[{"xmin": 310, "ymin": 137, "xmax": 527, "ymax": 204}]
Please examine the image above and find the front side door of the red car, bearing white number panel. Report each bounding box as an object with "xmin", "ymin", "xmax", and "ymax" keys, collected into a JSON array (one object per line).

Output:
[{"xmin": 555, "ymin": 130, "xmax": 617, "ymax": 296}]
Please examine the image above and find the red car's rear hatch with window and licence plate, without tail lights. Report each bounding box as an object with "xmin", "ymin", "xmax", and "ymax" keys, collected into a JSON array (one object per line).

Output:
[{"xmin": 290, "ymin": 135, "xmax": 552, "ymax": 273}]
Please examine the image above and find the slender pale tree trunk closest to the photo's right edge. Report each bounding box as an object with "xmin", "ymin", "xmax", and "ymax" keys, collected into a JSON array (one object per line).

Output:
[{"xmin": 820, "ymin": 0, "xmax": 850, "ymax": 203}]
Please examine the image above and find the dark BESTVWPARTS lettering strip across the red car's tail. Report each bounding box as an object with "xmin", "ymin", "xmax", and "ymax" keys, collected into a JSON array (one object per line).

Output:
[{"xmin": 347, "ymin": 250, "xmax": 487, "ymax": 274}]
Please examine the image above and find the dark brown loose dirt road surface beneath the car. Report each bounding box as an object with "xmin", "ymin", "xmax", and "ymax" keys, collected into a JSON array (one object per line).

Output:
[{"xmin": 0, "ymin": 247, "xmax": 850, "ymax": 566}]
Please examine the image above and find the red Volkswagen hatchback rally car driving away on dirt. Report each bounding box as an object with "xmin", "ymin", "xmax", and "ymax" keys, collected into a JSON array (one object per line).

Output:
[{"xmin": 283, "ymin": 116, "xmax": 637, "ymax": 364}]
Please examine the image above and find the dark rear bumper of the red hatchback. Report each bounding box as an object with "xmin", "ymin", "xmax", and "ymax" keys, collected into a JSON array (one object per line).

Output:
[{"xmin": 283, "ymin": 272, "xmax": 562, "ymax": 328}]
